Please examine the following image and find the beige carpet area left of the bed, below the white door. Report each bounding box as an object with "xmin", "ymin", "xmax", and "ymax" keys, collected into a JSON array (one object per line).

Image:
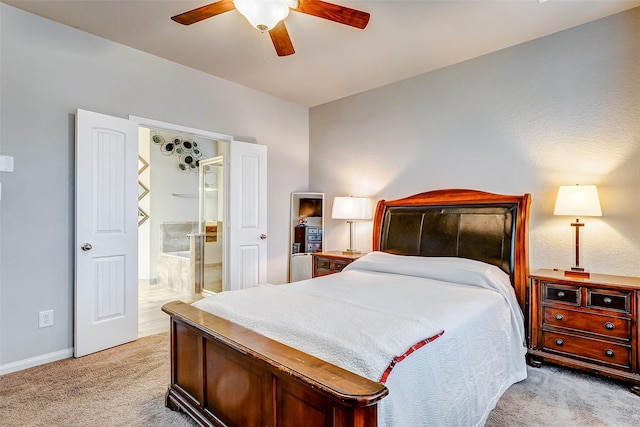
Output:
[{"xmin": 0, "ymin": 333, "xmax": 194, "ymax": 427}]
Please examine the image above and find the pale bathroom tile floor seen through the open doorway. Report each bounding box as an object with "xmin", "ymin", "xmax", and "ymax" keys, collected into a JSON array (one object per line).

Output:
[{"xmin": 138, "ymin": 282, "xmax": 192, "ymax": 337}]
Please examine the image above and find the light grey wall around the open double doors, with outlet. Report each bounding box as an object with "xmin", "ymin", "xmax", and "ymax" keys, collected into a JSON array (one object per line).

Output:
[{"xmin": 0, "ymin": 3, "xmax": 309, "ymax": 371}]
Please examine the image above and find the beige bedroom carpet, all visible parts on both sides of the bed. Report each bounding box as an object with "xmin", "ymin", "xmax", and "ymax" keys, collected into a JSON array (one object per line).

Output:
[{"xmin": 0, "ymin": 334, "xmax": 640, "ymax": 427}]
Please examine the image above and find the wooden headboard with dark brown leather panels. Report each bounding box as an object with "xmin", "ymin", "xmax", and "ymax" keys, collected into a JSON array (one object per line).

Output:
[{"xmin": 373, "ymin": 189, "xmax": 531, "ymax": 310}]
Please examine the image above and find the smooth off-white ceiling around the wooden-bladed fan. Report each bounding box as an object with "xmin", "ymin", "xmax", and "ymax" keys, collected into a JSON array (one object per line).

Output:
[{"xmin": 2, "ymin": 0, "xmax": 640, "ymax": 107}]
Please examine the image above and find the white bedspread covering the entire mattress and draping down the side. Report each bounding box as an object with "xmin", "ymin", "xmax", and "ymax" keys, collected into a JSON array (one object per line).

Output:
[{"xmin": 194, "ymin": 252, "xmax": 526, "ymax": 427}]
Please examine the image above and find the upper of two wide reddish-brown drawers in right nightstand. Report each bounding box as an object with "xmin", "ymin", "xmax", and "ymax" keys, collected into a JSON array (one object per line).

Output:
[{"xmin": 542, "ymin": 307, "xmax": 631, "ymax": 340}]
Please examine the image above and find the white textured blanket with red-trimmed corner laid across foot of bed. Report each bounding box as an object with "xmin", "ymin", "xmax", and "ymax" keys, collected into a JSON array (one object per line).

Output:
[{"xmin": 193, "ymin": 285, "xmax": 443, "ymax": 381}]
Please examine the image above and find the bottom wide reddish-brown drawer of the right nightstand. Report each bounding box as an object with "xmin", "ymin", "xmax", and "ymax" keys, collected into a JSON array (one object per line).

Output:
[{"xmin": 543, "ymin": 332, "xmax": 631, "ymax": 368}]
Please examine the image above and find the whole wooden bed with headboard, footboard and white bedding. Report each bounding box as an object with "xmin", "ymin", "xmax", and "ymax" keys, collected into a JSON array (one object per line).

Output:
[{"xmin": 163, "ymin": 190, "xmax": 530, "ymax": 426}]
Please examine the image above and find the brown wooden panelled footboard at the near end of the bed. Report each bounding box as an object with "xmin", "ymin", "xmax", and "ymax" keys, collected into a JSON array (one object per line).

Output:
[{"xmin": 162, "ymin": 301, "xmax": 388, "ymax": 427}]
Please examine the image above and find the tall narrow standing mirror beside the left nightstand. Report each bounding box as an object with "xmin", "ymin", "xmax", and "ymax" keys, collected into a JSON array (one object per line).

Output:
[{"xmin": 289, "ymin": 193, "xmax": 325, "ymax": 282}]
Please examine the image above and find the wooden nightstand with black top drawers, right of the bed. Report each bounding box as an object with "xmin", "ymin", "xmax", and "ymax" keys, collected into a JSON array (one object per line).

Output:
[{"xmin": 528, "ymin": 270, "xmax": 640, "ymax": 395}]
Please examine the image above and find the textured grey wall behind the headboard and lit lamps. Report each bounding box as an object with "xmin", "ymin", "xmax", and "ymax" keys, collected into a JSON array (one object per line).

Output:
[{"xmin": 309, "ymin": 8, "xmax": 640, "ymax": 276}]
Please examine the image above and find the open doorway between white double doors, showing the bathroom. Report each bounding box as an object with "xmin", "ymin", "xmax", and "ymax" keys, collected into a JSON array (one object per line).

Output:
[{"xmin": 138, "ymin": 124, "xmax": 229, "ymax": 337}]
